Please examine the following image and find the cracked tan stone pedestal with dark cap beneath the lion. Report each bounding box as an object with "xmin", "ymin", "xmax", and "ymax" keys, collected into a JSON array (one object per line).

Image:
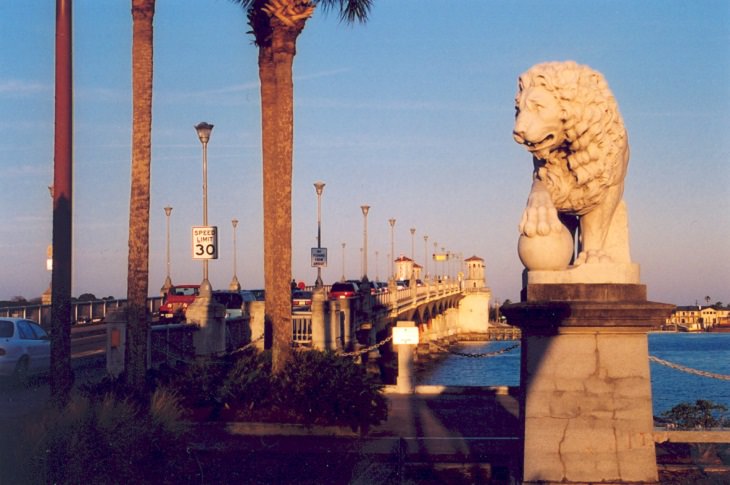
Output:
[{"xmin": 502, "ymin": 283, "xmax": 673, "ymax": 484}]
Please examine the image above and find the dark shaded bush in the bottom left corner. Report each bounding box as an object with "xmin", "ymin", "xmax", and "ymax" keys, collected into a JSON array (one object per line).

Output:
[{"xmin": 18, "ymin": 390, "xmax": 187, "ymax": 483}]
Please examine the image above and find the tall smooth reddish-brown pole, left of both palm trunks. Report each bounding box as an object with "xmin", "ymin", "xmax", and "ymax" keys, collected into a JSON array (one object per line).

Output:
[{"xmin": 50, "ymin": 0, "xmax": 73, "ymax": 405}]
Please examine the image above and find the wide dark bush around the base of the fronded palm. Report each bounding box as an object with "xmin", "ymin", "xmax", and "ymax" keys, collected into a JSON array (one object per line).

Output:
[{"xmin": 158, "ymin": 349, "xmax": 388, "ymax": 431}]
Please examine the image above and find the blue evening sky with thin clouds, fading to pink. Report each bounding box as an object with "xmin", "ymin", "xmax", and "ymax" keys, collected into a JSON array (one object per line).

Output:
[{"xmin": 0, "ymin": 0, "xmax": 730, "ymax": 304}]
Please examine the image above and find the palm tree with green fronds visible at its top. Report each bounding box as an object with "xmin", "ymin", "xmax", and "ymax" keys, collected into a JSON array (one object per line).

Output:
[{"xmin": 233, "ymin": 0, "xmax": 372, "ymax": 372}]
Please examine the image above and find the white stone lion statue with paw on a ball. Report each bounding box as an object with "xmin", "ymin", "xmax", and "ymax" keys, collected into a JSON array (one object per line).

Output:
[{"xmin": 513, "ymin": 61, "xmax": 631, "ymax": 270}]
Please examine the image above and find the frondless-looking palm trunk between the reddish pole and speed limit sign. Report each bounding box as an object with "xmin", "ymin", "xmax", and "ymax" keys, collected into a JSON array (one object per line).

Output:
[{"xmin": 125, "ymin": 0, "xmax": 155, "ymax": 390}]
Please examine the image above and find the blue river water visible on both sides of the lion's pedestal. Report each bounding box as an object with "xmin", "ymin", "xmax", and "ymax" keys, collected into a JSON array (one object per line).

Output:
[{"xmin": 418, "ymin": 332, "xmax": 730, "ymax": 415}]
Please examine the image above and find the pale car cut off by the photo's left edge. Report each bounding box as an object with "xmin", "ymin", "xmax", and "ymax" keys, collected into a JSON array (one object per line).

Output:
[{"xmin": 0, "ymin": 317, "xmax": 51, "ymax": 382}]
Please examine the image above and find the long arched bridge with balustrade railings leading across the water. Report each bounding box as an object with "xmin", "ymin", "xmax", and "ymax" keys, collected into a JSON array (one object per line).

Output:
[{"xmin": 0, "ymin": 280, "xmax": 494, "ymax": 364}]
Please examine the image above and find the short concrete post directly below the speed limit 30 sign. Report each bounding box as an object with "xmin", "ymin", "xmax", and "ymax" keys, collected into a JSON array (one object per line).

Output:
[{"xmin": 185, "ymin": 295, "xmax": 226, "ymax": 355}]
